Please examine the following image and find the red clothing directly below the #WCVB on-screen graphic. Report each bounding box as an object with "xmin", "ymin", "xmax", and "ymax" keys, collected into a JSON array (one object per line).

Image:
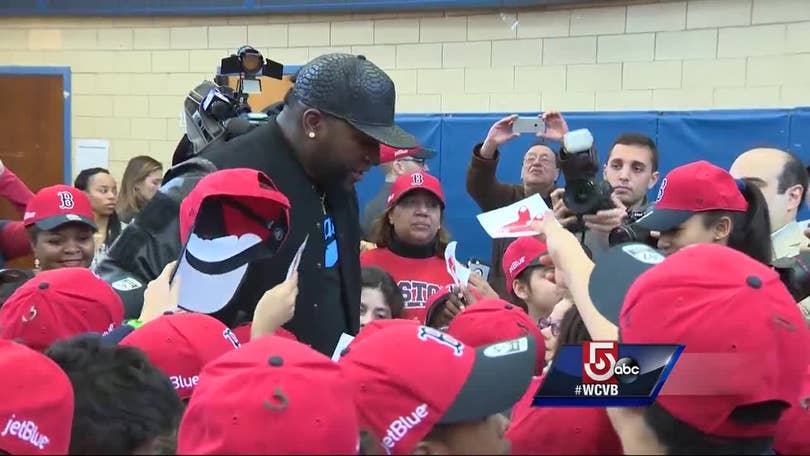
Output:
[{"xmin": 506, "ymin": 377, "xmax": 624, "ymax": 455}]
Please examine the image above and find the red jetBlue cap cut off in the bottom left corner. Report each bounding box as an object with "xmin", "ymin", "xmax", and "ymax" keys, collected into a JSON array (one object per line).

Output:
[{"xmin": 0, "ymin": 340, "xmax": 73, "ymax": 454}]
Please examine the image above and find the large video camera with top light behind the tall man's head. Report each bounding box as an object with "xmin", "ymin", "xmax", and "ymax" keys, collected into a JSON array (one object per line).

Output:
[{"xmin": 181, "ymin": 46, "xmax": 284, "ymax": 161}]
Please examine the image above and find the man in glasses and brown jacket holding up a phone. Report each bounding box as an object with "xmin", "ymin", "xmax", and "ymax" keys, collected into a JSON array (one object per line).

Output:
[{"xmin": 467, "ymin": 111, "xmax": 568, "ymax": 296}]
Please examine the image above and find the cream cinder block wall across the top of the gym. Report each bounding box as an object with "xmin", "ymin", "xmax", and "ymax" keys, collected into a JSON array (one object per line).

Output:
[{"xmin": 0, "ymin": 0, "xmax": 810, "ymax": 177}]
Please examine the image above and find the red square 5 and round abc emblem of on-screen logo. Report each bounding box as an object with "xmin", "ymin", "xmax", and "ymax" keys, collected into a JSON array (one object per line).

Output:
[{"xmin": 582, "ymin": 342, "xmax": 641, "ymax": 384}]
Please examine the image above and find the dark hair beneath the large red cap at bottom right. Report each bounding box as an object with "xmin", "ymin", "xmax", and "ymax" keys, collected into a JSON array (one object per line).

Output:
[{"xmin": 644, "ymin": 401, "xmax": 787, "ymax": 455}]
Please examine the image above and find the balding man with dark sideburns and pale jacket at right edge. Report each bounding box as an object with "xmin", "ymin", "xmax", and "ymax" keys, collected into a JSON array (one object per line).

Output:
[{"xmin": 729, "ymin": 148, "xmax": 810, "ymax": 325}]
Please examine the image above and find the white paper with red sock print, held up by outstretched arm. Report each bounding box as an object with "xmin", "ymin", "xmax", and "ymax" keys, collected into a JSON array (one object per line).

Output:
[{"xmin": 478, "ymin": 193, "xmax": 549, "ymax": 239}]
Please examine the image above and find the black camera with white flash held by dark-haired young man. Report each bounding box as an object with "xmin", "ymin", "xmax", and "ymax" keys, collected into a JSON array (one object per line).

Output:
[{"xmin": 560, "ymin": 129, "xmax": 613, "ymax": 232}]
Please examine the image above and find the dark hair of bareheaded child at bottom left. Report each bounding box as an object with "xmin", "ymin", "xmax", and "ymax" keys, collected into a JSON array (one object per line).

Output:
[{"xmin": 45, "ymin": 337, "xmax": 183, "ymax": 454}]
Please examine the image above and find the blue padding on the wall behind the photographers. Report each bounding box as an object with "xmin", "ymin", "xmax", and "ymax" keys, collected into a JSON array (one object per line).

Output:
[{"xmin": 357, "ymin": 109, "xmax": 810, "ymax": 260}]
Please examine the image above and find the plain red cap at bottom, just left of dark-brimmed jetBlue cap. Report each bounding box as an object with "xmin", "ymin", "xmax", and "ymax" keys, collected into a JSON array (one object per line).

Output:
[{"xmin": 177, "ymin": 336, "xmax": 360, "ymax": 454}]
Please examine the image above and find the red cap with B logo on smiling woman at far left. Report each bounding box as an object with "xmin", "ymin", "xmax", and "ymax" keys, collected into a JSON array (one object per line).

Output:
[{"xmin": 23, "ymin": 185, "xmax": 97, "ymax": 231}]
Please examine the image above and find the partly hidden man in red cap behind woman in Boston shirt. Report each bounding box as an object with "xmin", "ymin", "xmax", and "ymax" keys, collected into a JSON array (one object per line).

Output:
[{"xmin": 361, "ymin": 144, "xmax": 436, "ymax": 242}]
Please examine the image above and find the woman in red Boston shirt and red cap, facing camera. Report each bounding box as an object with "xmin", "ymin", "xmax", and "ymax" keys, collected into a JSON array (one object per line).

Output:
[{"xmin": 360, "ymin": 172, "xmax": 453, "ymax": 321}]
